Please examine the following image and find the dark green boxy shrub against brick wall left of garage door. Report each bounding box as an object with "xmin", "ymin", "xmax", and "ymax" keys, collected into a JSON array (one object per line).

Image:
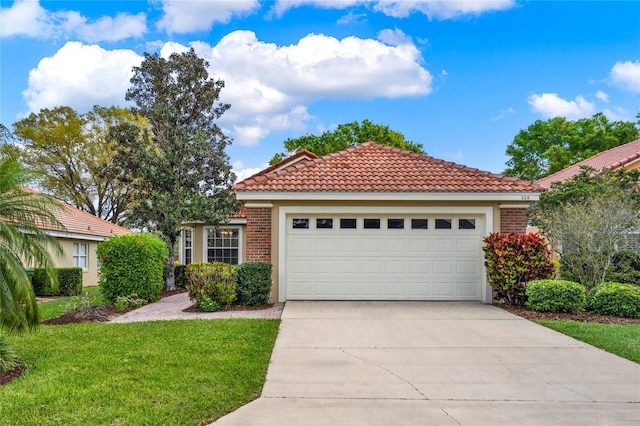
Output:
[{"xmin": 236, "ymin": 262, "xmax": 272, "ymax": 306}]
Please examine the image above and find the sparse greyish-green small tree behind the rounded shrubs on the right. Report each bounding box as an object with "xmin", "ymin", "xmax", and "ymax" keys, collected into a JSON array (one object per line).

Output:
[{"xmin": 531, "ymin": 168, "xmax": 640, "ymax": 288}]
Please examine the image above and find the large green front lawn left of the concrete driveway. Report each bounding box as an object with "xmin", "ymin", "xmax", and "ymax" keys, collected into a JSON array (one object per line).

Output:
[{"xmin": 0, "ymin": 319, "xmax": 279, "ymax": 425}]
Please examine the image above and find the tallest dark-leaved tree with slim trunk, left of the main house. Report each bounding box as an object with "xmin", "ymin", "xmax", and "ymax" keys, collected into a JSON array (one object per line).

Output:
[{"xmin": 119, "ymin": 49, "xmax": 237, "ymax": 289}]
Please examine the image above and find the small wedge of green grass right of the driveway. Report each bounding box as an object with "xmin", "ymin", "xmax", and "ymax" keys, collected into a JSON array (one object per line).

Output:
[{"xmin": 536, "ymin": 321, "xmax": 640, "ymax": 363}]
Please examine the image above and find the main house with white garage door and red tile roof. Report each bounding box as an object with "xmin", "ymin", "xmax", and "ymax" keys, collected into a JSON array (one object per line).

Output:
[{"xmin": 182, "ymin": 142, "xmax": 540, "ymax": 303}]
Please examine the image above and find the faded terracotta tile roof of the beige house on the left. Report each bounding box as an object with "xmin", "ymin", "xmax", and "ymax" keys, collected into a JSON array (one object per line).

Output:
[{"xmin": 25, "ymin": 188, "xmax": 133, "ymax": 238}]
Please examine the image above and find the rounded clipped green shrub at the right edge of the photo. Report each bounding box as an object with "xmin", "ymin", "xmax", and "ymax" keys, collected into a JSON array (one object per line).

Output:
[{"xmin": 587, "ymin": 283, "xmax": 640, "ymax": 318}]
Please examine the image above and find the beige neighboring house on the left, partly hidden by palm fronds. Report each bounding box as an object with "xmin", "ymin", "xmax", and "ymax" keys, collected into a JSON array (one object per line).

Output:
[{"xmin": 29, "ymin": 191, "xmax": 132, "ymax": 287}]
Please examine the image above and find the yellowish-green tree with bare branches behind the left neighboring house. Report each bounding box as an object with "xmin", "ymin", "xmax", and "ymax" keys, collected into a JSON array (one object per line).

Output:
[{"xmin": 13, "ymin": 106, "xmax": 145, "ymax": 223}]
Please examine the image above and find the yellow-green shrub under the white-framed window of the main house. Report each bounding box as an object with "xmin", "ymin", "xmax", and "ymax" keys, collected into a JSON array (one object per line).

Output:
[{"xmin": 186, "ymin": 262, "xmax": 236, "ymax": 309}]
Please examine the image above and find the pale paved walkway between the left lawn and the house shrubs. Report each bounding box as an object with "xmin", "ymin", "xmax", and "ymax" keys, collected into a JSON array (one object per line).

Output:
[{"xmin": 111, "ymin": 293, "xmax": 283, "ymax": 322}]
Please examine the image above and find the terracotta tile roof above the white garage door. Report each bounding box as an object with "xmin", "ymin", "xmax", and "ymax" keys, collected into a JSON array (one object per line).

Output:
[{"xmin": 232, "ymin": 142, "xmax": 541, "ymax": 192}]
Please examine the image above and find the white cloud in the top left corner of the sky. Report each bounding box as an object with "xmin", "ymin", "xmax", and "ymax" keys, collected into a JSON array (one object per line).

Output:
[{"xmin": 0, "ymin": 0, "xmax": 147, "ymax": 43}]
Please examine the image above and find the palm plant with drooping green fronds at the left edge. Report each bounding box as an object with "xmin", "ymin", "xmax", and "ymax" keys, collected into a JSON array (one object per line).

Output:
[{"xmin": 0, "ymin": 151, "xmax": 64, "ymax": 333}]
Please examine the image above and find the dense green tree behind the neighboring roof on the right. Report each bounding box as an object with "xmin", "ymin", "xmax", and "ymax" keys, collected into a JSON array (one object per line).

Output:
[{"xmin": 504, "ymin": 113, "xmax": 640, "ymax": 180}]
